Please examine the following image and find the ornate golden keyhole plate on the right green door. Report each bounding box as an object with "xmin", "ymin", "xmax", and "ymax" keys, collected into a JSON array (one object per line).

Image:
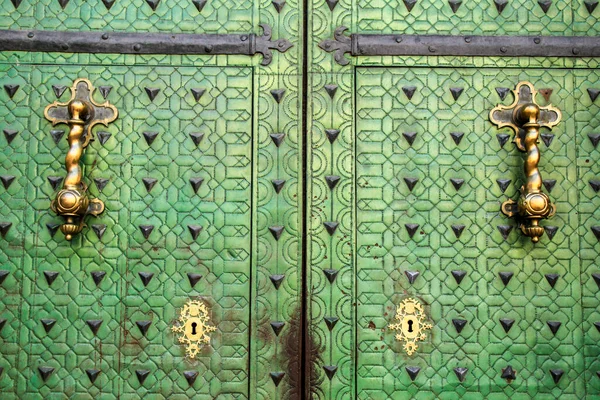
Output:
[{"xmin": 389, "ymin": 298, "xmax": 433, "ymax": 356}]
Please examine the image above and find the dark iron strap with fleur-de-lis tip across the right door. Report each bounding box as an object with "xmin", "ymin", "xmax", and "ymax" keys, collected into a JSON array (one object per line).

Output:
[{"xmin": 319, "ymin": 26, "xmax": 600, "ymax": 65}]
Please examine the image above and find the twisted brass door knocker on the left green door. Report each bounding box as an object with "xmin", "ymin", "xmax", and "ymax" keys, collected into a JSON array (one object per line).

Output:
[{"xmin": 44, "ymin": 79, "xmax": 118, "ymax": 240}]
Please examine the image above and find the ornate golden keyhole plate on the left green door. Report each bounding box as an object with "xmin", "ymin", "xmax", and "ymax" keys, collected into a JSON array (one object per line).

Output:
[{"xmin": 171, "ymin": 300, "xmax": 217, "ymax": 358}]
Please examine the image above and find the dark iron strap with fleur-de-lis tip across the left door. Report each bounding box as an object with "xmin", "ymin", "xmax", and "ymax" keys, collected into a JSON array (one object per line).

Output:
[{"xmin": 0, "ymin": 24, "xmax": 292, "ymax": 65}]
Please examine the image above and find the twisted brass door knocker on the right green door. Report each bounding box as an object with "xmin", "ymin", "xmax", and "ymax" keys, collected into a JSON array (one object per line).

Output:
[{"xmin": 490, "ymin": 82, "xmax": 562, "ymax": 243}]
